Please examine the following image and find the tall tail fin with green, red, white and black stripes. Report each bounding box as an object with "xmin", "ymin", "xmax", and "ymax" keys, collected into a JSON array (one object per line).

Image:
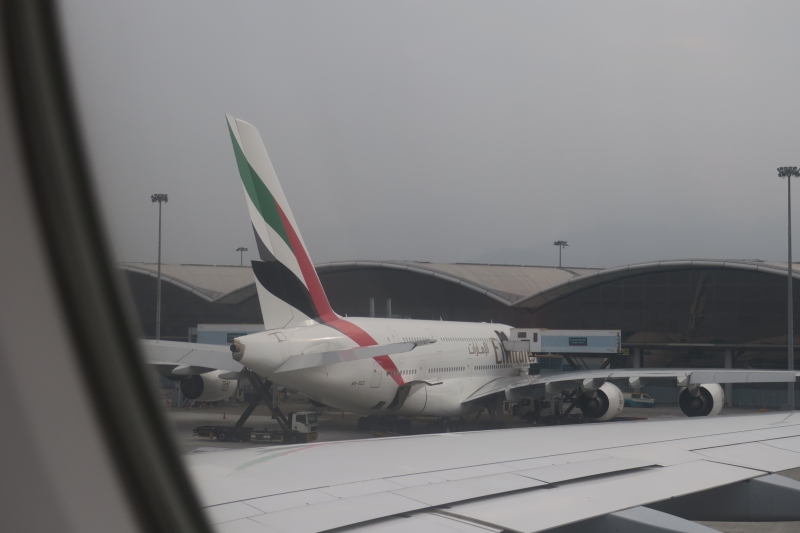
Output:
[{"xmin": 226, "ymin": 115, "xmax": 338, "ymax": 329}]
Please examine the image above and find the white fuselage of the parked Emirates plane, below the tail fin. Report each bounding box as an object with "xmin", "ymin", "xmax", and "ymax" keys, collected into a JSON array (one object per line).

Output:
[{"xmin": 238, "ymin": 318, "xmax": 528, "ymax": 417}]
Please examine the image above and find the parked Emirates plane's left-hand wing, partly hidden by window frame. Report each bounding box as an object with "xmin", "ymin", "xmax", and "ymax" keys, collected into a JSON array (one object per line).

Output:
[{"xmin": 140, "ymin": 340, "xmax": 243, "ymax": 375}]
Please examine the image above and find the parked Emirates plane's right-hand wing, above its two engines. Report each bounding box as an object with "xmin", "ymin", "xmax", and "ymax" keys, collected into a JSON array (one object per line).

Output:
[{"xmin": 464, "ymin": 368, "xmax": 800, "ymax": 403}]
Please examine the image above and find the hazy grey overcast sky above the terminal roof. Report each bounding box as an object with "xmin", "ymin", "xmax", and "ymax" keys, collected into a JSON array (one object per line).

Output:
[{"xmin": 56, "ymin": 0, "xmax": 800, "ymax": 267}]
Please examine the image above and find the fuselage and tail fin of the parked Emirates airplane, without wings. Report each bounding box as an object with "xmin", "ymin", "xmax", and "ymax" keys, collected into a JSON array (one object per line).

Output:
[{"xmin": 227, "ymin": 116, "xmax": 529, "ymax": 417}]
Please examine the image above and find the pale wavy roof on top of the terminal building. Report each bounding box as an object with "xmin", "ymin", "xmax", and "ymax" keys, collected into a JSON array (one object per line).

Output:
[{"xmin": 120, "ymin": 259, "xmax": 800, "ymax": 309}]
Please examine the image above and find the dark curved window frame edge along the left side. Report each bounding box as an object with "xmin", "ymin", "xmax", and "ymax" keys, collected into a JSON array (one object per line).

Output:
[{"xmin": 0, "ymin": 4, "xmax": 211, "ymax": 533}]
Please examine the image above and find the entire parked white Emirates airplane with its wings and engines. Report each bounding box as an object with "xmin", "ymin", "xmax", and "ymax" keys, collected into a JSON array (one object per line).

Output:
[{"xmin": 149, "ymin": 116, "xmax": 795, "ymax": 421}]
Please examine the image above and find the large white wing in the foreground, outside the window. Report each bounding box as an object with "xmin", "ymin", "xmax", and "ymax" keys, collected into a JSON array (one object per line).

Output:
[{"xmin": 186, "ymin": 413, "xmax": 800, "ymax": 533}]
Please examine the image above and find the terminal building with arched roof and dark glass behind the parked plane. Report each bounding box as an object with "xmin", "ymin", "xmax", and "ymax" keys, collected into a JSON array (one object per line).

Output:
[{"xmin": 120, "ymin": 260, "xmax": 800, "ymax": 407}]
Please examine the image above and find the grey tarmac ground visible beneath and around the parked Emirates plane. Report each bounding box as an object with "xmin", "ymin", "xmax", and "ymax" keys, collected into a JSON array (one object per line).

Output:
[{"xmin": 166, "ymin": 400, "xmax": 800, "ymax": 533}]
